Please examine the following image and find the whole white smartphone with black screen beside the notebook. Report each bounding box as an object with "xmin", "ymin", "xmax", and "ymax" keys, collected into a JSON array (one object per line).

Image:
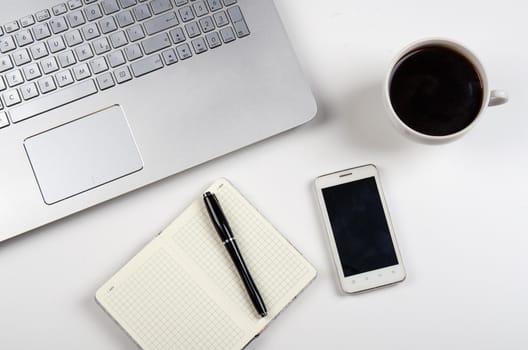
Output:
[{"xmin": 315, "ymin": 165, "xmax": 406, "ymax": 293}]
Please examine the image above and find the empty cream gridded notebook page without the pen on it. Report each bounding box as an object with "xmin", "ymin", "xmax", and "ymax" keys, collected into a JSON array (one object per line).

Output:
[{"xmin": 105, "ymin": 249, "xmax": 244, "ymax": 350}]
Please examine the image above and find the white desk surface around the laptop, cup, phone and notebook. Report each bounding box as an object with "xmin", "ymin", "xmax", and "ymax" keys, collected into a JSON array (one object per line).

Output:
[{"xmin": 0, "ymin": 0, "xmax": 528, "ymax": 350}]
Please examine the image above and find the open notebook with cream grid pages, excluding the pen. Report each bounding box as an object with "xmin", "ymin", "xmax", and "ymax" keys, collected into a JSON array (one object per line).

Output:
[{"xmin": 96, "ymin": 179, "xmax": 316, "ymax": 350}]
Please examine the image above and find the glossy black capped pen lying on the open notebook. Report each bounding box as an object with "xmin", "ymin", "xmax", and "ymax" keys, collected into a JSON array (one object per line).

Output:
[{"xmin": 204, "ymin": 192, "xmax": 268, "ymax": 317}]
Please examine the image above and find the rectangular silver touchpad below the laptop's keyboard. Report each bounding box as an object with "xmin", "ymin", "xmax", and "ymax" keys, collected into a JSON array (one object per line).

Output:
[{"xmin": 24, "ymin": 106, "xmax": 143, "ymax": 204}]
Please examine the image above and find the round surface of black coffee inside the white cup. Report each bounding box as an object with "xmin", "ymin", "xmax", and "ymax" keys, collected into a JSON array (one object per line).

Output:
[{"xmin": 390, "ymin": 46, "xmax": 483, "ymax": 136}]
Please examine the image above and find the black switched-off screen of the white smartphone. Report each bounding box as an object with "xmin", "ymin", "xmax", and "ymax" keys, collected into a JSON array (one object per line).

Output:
[{"xmin": 322, "ymin": 177, "xmax": 398, "ymax": 277}]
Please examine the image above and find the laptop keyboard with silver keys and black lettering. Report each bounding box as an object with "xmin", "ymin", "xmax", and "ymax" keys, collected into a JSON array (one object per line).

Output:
[{"xmin": 0, "ymin": 0, "xmax": 250, "ymax": 129}]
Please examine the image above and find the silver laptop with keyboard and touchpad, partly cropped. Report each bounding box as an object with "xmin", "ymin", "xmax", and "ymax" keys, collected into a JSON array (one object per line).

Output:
[{"xmin": 0, "ymin": 0, "xmax": 316, "ymax": 241}]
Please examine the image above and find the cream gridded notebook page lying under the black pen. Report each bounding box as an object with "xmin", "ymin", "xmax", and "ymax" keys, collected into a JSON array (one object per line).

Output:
[{"xmin": 172, "ymin": 183, "xmax": 312, "ymax": 319}]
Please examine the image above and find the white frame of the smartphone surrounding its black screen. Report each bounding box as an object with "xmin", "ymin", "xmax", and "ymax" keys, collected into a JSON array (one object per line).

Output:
[{"xmin": 315, "ymin": 164, "xmax": 406, "ymax": 293}]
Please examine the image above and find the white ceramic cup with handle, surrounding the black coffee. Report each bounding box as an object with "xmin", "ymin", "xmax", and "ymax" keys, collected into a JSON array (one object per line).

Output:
[{"xmin": 383, "ymin": 38, "xmax": 508, "ymax": 144}]
